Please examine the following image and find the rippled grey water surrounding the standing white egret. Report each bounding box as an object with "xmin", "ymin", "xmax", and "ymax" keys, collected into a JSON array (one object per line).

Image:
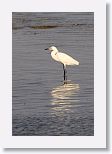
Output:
[{"xmin": 12, "ymin": 12, "xmax": 94, "ymax": 136}]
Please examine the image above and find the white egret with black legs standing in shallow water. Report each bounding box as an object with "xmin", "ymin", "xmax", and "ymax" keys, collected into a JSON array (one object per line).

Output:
[{"xmin": 45, "ymin": 46, "xmax": 79, "ymax": 83}]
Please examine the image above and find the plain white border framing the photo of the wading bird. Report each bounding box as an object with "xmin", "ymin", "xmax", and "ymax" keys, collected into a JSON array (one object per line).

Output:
[{"xmin": 0, "ymin": 0, "xmax": 106, "ymax": 148}]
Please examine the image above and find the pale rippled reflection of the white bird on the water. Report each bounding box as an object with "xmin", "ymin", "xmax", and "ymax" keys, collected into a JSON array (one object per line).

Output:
[{"xmin": 51, "ymin": 83, "xmax": 80, "ymax": 116}]
